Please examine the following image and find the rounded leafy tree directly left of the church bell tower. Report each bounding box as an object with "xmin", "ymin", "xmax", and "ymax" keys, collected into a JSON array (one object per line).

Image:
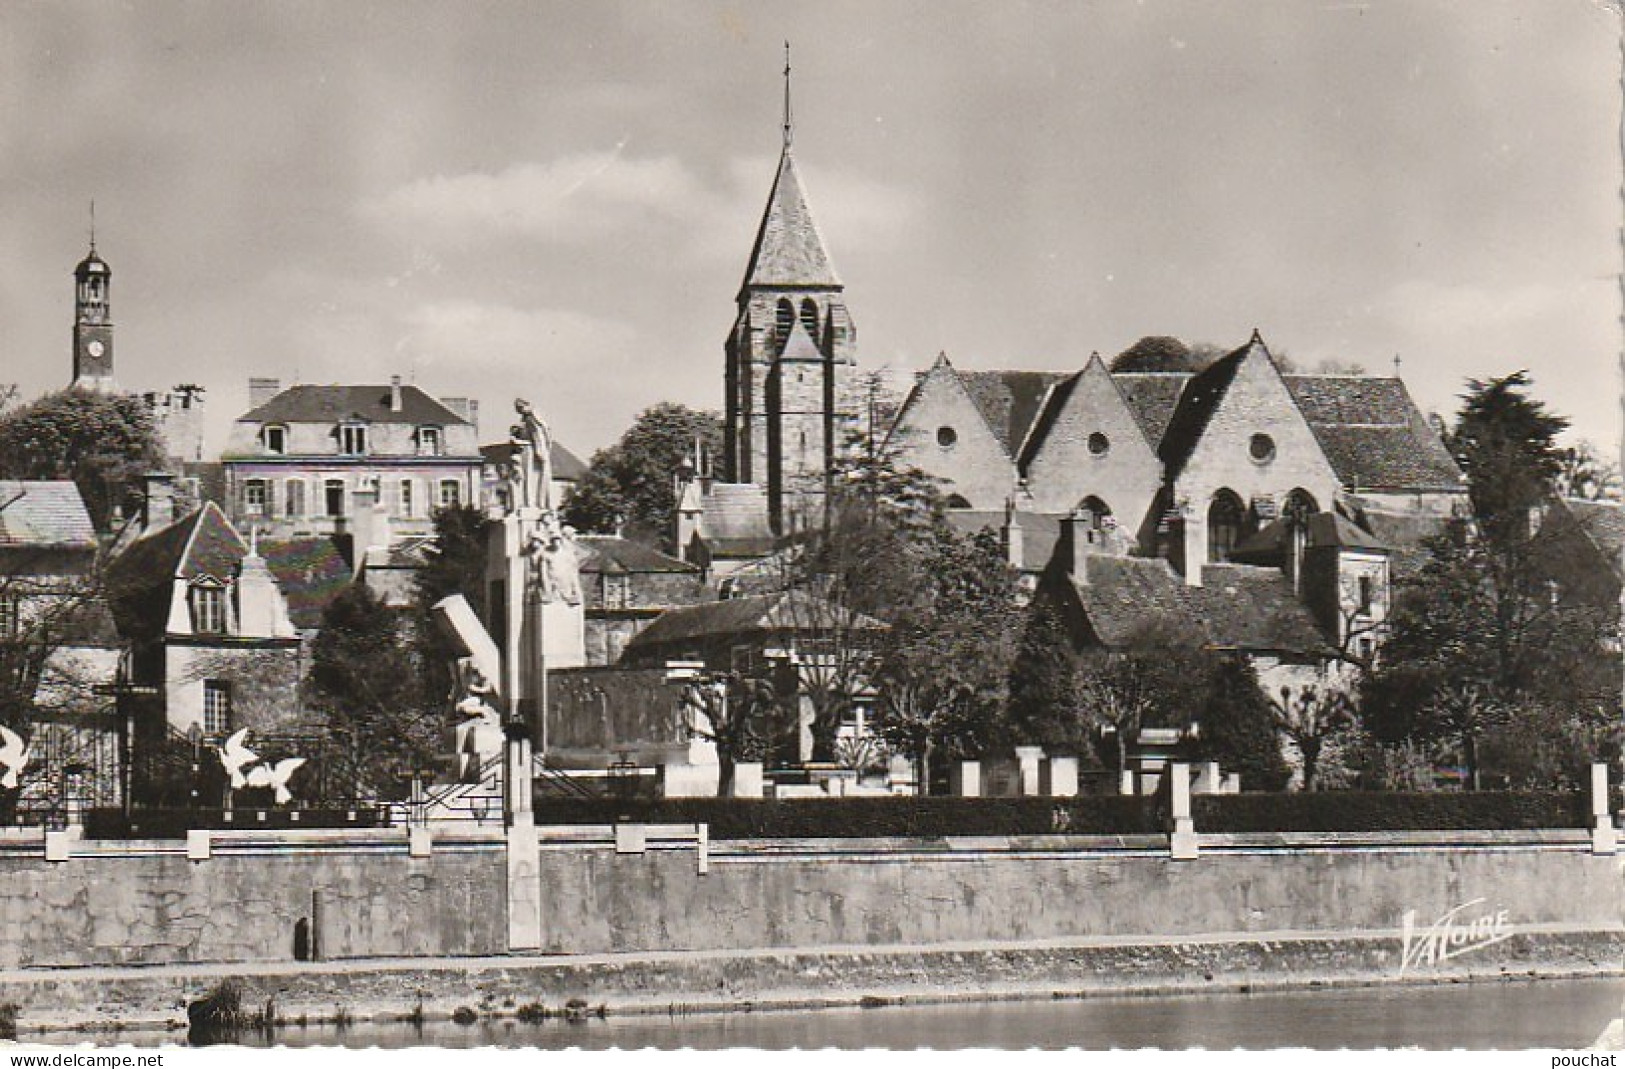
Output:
[{"xmin": 562, "ymin": 401, "xmax": 723, "ymax": 546}]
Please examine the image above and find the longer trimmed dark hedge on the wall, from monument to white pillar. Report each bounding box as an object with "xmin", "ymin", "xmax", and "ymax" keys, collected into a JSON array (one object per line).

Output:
[{"xmin": 536, "ymin": 796, "xmax": 1164, "ymax": 838}]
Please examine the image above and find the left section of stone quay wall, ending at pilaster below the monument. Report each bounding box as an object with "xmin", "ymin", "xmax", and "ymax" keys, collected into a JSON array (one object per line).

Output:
[{"xmin": 0, "ymin": 830, "xmax": 507, "ymax": 970}]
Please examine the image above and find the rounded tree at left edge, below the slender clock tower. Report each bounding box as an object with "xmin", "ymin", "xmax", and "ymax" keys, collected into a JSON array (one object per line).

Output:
[{"xmin": 0, "ymin": 388, "xmax": 163, "ymax": 531}]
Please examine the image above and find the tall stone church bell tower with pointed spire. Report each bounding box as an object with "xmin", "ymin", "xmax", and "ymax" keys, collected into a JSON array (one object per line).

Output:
[{"xmin": 725, "ymin": 45, "xmax": 856, "ymax": 535}]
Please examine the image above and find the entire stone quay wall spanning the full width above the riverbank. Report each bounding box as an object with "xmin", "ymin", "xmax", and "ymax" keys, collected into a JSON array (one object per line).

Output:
[{"xmin": 0, "ymin": 825, "xmax": 1625, "ymax": 970}]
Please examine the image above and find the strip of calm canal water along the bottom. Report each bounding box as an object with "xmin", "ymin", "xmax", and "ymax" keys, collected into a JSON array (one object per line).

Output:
[{"xmin": 80, "ymin": 978, "xmax": 1625, "ymax": 1050}]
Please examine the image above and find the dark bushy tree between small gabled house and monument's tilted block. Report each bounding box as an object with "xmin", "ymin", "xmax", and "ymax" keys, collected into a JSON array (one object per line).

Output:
[{"xmin": 309, "ymin": 583, "xmax": 445, "ymax": 796}]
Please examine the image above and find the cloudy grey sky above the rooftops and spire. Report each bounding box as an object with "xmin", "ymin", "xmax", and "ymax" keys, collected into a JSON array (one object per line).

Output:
[{"xmin": 0, "ymin": 0, "xmax": 1622, "ymax": 455}]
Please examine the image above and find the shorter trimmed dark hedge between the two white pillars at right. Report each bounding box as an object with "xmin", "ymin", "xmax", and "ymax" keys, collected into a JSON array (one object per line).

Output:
[{"xmin": 1191, "ymin": 791, "xmax": 1591, "ymax": 833}]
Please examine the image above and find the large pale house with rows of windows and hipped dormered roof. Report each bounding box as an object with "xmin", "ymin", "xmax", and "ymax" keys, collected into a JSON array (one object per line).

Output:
[{"xmin": 221, "ymin": 377, "xmax": 483, "ymax": 549}]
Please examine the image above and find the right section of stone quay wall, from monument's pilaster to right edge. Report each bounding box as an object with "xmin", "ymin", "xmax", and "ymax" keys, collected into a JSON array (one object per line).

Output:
[{"xmin": 526, "ymin": 832, "xmax": 1625, "ymax": 963}]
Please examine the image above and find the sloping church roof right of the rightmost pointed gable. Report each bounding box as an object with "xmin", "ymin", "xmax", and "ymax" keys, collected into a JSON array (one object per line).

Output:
[{"xmin": 1284, "ymin": 375, "xmax": 1464, "ymax": 491}]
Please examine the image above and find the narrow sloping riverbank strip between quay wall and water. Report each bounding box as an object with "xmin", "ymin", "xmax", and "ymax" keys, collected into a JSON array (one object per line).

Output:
[{"xmin": 0, "ymin": 926, "xmax": 1625, "ymax": 1041}]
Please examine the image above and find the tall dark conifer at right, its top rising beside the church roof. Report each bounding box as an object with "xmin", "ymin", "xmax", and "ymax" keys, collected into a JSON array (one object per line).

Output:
[{"xmin": 1362, "ymin": 372, "xmax": 1619, "ymax": 788}]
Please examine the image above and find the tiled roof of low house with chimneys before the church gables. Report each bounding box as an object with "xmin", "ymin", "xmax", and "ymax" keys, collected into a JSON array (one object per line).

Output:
[{"xmin": 1069, "ymin": 556, "xmax": 1326, "ymax": 655}]
